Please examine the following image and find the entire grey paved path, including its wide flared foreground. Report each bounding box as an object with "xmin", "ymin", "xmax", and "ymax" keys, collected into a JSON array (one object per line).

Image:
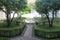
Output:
[{"xmin": 10, "ymin": 24, "xmax": 40, "ymax": 40}]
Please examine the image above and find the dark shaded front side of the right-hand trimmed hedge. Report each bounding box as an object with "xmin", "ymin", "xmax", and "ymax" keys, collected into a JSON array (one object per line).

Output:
[{"xmin": 35, "ymin": 30, "xmax": 60, "ymax": 38}]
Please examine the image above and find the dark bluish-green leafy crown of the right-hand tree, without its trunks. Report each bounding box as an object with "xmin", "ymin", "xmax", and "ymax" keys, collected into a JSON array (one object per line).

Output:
[{"xmin": 36, "ymin": 0, "xmax": 60, "ymax": 13}]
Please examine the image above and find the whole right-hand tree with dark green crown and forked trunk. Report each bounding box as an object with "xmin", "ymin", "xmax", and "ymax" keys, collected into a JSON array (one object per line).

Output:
[{"xmin": 35, "ymin": 0, "xmax": 60, "ymax": 27}]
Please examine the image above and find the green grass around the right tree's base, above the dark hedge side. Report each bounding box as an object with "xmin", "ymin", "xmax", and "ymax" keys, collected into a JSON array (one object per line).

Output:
[{"xmin": 34, "ymin": 24, "xmax": 60, "ymax": 32}]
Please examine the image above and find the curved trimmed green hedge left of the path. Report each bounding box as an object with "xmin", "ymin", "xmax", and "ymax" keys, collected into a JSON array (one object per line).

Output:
[{"xmin": 0, "ymin": 25, "xmax": 24, "ymax": 37}]
